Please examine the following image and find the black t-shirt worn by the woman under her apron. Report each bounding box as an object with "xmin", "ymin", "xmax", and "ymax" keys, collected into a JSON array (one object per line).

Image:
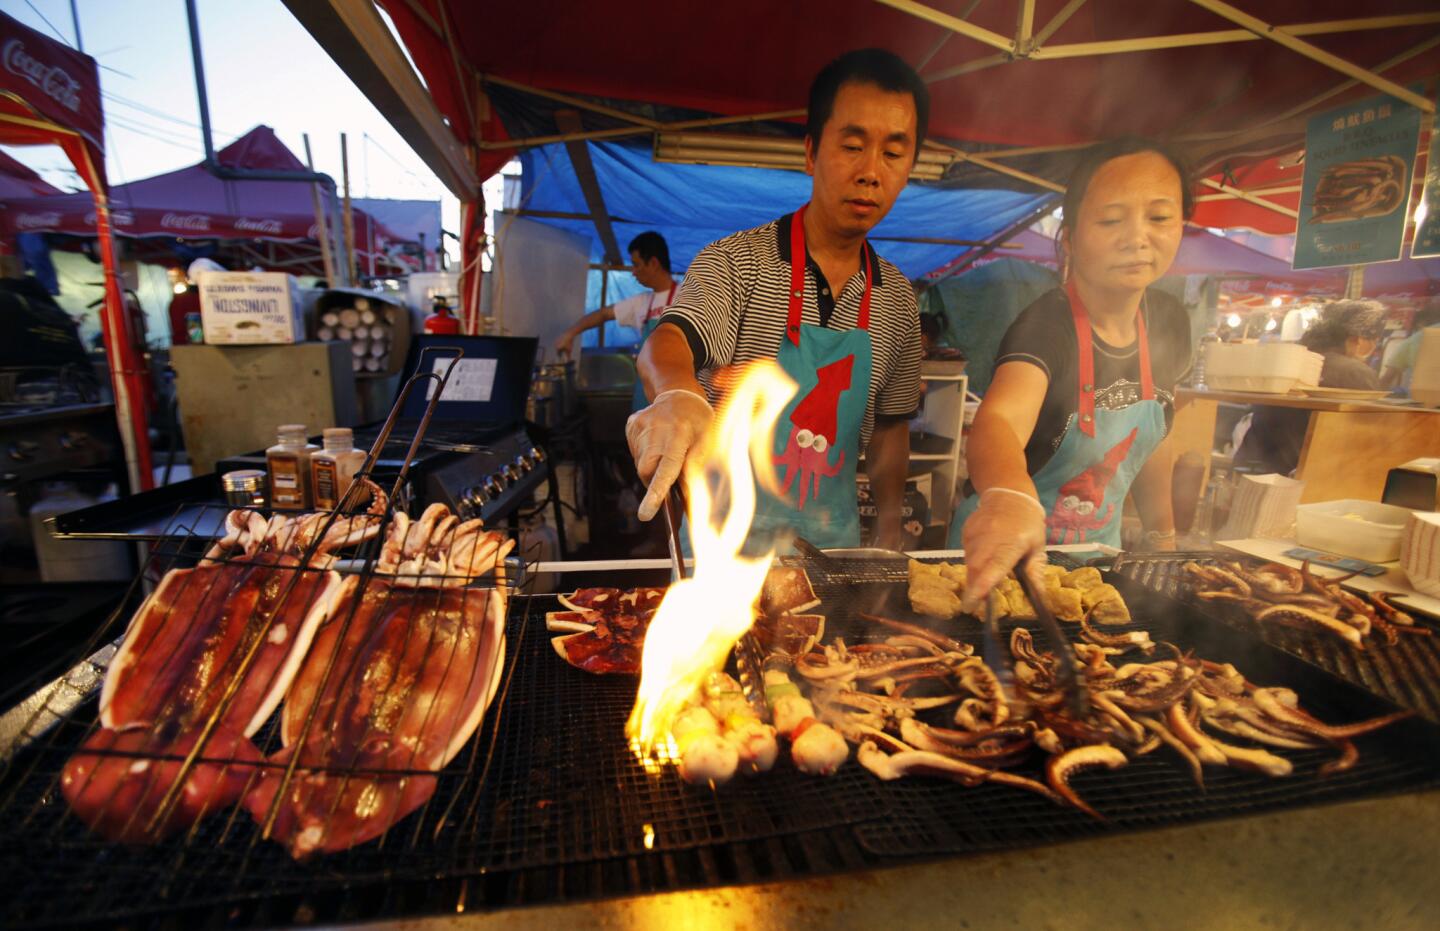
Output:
[{"xmin": 995, "ymin": 288, "xmax": 1191, "ymax": 475}]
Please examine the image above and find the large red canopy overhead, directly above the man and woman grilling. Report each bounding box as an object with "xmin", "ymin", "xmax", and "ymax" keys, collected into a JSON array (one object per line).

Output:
[{"xmin": 277, "ymin": 0, "xmax": 1440, "ymax": 330}]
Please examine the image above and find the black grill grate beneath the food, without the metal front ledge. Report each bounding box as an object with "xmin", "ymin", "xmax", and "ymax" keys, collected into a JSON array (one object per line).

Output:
[{"xmin": 0, "ymin": 549, "xmax": 1440, "ymax": 927}]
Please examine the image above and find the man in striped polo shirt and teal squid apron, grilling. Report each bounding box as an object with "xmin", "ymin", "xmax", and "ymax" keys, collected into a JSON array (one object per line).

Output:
[{"xmin": 625, "ymin": 49, "xmax": 929, "ymax": 547}]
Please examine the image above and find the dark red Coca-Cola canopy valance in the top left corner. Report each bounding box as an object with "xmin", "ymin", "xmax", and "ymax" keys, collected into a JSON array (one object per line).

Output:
[{"xmin": 0, "ymin": 13, "xmax": 105, "ymax": 153}]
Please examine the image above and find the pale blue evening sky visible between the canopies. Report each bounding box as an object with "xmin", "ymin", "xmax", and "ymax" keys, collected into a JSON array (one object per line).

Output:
[{"xmin": 0, "ymin": 0, "xmax": 459, "ymax": 254}]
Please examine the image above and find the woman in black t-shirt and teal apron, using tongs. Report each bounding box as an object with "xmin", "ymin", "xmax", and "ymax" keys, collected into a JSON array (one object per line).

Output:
[{"xmin": 950, "ymin": 138, "xmax": 1194, "ymax": 610}]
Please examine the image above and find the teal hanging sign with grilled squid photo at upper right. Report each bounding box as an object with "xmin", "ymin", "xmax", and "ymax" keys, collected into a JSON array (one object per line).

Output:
[{"xmin": 1295, "ymin": 88, "xmax": 1420, "ymax": 269}]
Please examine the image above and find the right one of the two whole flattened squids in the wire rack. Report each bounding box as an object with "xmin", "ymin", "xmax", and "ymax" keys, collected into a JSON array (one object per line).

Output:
[{"xmin": 245, "ymin": 505, "xmax": 514, "ymax": 859}]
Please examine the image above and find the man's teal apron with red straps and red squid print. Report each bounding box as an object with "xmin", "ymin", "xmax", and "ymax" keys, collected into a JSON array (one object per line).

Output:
[{"xmin": 681, "ymin": 207, "xmax": 874, "ymax": 555}]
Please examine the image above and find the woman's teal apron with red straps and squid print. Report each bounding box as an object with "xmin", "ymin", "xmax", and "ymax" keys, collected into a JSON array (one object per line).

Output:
[{"xmin": 949, "ymin": 282, "xmax": 1165, "ymax": 548}]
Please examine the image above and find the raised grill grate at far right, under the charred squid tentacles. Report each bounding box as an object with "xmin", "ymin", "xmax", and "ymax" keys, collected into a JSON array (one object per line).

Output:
[{"xmin": 1115, "ymin": 553, "xmax": 1440, "ymax": 724}]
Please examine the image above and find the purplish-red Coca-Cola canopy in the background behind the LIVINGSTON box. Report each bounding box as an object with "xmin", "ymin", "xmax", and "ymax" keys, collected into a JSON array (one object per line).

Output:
[{"xmin": 0, "ymin": 125, "xmax": 408, "ymax": 273}]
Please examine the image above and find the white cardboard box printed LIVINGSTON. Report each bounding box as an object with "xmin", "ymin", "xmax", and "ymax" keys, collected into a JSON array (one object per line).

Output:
[{"xmin": 199, "ymin": 272, "xmax": 305, "ymax": 345}]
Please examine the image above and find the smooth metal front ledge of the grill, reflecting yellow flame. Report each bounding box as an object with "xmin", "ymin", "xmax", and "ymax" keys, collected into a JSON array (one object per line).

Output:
[{"xmin": 357, "ymin": 791, "xmax": 1440, "ymax": 931}]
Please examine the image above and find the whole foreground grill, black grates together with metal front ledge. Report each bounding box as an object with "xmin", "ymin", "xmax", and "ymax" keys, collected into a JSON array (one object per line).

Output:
[{"xmin": 0, "ymin": 554, "xmax": 1440, "ymax": 931}]
